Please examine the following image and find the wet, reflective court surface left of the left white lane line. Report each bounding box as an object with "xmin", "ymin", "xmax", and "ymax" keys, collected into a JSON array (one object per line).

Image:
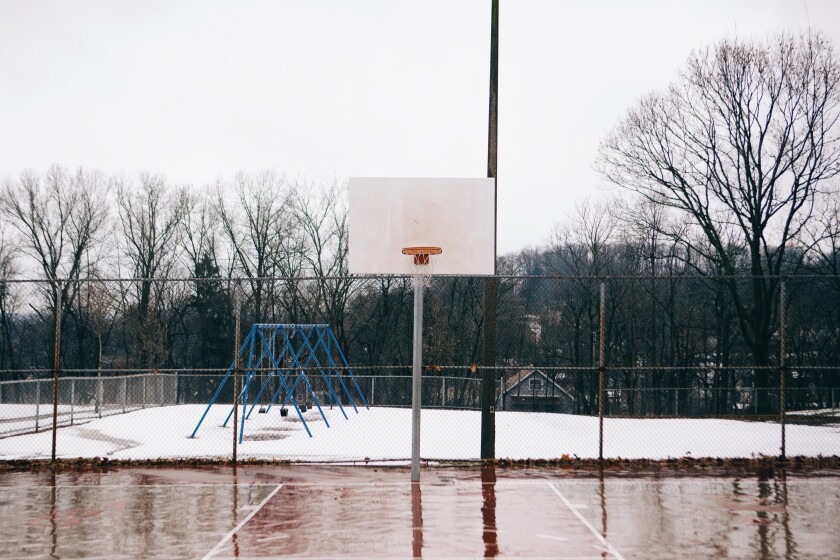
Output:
[{"xmin": 0, "ymin": 475, "xmax": 272, "ymax": 558}]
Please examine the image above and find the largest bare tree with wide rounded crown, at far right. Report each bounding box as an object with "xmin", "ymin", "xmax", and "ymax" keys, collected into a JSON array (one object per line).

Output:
[{"xmin": 598, "ymin": 35, "xmax": 840, "ymax": 412}]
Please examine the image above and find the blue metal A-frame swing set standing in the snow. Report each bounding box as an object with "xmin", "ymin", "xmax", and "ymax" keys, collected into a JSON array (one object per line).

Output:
[{"xmin": 190, "ymin": 323, "xmax": 370, "ymax": 443}]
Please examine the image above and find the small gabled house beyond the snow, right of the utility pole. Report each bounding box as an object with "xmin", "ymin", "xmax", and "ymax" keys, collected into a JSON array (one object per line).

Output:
[{"xmin": 496, "ymin": 369, "xmax": 575, "ymax": 413}]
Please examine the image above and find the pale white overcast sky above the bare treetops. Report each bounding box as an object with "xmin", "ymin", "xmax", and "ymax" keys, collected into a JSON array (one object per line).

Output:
[{"xmin": 0, "ymin": 0, "xmax": 840, "ymax": 253}]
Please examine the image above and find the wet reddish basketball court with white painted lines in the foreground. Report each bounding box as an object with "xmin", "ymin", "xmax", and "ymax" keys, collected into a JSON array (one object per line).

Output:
[{"xmin": 0, "ymin": 465, "xmax": 840, "ymax": 559}]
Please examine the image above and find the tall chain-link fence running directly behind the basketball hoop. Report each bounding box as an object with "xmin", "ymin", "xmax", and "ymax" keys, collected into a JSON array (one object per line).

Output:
[{"xmin": 0, "ymin": 275, "xmax": 840, "ymax": 461}]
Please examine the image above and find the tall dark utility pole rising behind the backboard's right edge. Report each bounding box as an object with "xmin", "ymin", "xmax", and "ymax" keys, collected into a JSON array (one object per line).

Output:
[{"xmin": 481, "ymin": 0, "xmax": 499, "ymax": 459}]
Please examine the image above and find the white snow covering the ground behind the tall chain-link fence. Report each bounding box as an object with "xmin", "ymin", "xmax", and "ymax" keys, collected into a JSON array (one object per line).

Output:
[{"xmin": 0, "ymin": 405, "xmax": 840, "ymax": 461}]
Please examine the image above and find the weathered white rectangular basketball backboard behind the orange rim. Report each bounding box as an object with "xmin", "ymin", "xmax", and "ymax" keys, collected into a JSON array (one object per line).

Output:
[{"xmin": 349, "ymin": 177, "xmax": 496, "ymax": 275}]
